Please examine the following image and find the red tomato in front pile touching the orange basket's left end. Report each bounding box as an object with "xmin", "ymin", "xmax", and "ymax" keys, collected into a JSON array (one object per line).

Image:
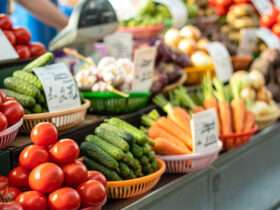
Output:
[{"xmin": 77, "ymin": 179, "xmax": 107, "ymax": 207}]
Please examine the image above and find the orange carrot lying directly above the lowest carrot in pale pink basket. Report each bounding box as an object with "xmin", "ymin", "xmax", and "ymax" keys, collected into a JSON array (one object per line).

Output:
[{"xmin": 148, "ymin": 123, "xmax": 186, "ymax": 147}]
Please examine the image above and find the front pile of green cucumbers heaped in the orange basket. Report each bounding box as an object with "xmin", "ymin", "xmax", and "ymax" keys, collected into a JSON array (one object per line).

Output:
[{"xmin": 81, "ymin": 118, "xmax": 158, "ymax": 181}]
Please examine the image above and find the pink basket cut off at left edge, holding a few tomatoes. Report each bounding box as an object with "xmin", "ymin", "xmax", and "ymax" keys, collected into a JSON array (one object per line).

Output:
[{"xmin": 0, "ymin": 119, "xmax": 23, "ymax": 149}]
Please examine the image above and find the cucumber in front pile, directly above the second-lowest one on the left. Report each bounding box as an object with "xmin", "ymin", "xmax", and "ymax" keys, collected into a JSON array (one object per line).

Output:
[{"xmin": 86, "ymin": 135, "xmax": 124, "ymax": 160}]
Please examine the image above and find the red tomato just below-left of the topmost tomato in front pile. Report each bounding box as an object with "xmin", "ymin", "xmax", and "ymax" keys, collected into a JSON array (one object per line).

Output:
[{"xmin": 19, "ymin": 145, "xmax": 49, "ymax": 170}]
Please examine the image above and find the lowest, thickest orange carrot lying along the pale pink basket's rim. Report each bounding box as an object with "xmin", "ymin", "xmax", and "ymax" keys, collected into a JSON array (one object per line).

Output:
[{"xmin": 154, "ymin": 137, "xmax": 191, "ymax": 155}]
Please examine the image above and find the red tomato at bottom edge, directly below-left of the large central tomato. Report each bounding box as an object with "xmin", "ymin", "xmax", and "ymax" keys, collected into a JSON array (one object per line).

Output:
[{"xmin": 16, "ymin": 191, "xmax": 47, "ymax": 210}]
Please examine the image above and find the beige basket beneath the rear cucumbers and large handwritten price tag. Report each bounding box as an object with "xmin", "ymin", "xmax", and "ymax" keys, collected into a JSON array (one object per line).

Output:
[{"xmin": 20, "ymin": 100, "xmax": 90, "ymax": 133}]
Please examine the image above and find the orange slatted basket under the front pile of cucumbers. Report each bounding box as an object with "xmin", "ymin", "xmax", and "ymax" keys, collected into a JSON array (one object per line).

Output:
[{"xmin": 107, "ymin": 159, "xmax": 166, "ymax": 199}]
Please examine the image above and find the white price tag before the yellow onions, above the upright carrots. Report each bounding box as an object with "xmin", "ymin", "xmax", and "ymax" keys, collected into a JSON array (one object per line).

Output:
[{"xmin": 207, "ymin": 42, "xmax": 233, "ymax": 81}]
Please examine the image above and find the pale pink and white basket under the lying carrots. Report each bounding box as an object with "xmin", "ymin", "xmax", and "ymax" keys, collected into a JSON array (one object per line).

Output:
[{"xmin": 159, "ymin": 141, "xmax": 223, "ymax": 174}]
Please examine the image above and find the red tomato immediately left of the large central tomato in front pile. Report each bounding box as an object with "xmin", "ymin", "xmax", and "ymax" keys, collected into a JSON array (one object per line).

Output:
[{"xmin": 8, "ymin": 166, "xmax": 29, "ymax": 188}]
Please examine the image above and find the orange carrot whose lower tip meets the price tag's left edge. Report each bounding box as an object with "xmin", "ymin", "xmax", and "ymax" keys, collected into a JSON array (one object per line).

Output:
[{"xmin": 157, "ymin": 117, "xmax": 192, "ymax": 149}]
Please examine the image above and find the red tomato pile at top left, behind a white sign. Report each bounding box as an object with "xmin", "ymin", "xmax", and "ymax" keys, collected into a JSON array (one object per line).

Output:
[{"xmin": 0, "ymin": 14, "xmax": 46, "ymax": 60}]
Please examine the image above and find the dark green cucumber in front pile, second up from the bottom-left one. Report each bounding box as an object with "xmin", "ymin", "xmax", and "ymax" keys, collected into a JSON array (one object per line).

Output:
[{"xmin": 80, "ymin": 142, "xmax": 119, "ymax": 170}]
